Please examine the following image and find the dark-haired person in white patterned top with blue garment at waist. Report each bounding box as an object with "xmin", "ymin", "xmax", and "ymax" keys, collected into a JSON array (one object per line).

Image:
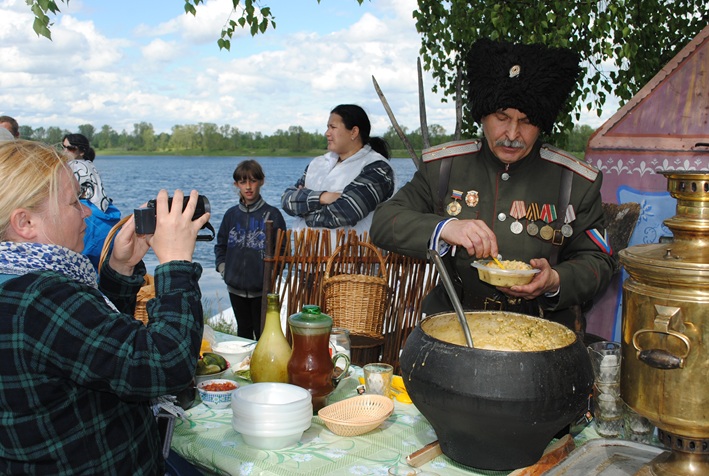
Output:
[{"xmin": 62, "ymin": 134, "xmax": 121, "ymax": 269}]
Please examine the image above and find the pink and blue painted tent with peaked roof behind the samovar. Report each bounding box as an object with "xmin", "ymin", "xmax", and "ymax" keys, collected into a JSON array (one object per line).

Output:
[{"xmin": 586, "ymin": 26, "xmax": 709, "ymax": 341}]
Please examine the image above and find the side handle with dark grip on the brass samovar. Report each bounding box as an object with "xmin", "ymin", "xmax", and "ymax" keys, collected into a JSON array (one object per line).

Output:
[{"xmin": 633, "ymin": 305, "xmax": 692, "ymax": 370}]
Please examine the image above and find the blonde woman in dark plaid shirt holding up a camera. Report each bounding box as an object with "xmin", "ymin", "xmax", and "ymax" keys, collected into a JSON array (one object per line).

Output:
[{"xmin": 0, "ymin": 140, "xmax": 209, "ymax": 475}]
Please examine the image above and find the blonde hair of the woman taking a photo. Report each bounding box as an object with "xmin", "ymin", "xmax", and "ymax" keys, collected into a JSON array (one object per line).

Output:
[{"xmin": 0, "ymin": 139, "xmax": 70, "ymax": 241}]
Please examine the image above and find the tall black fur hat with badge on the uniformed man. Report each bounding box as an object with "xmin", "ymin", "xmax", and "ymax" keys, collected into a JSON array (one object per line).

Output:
[{"xmin": 466, "ymin": 39, "xmax": 581, "ymax": 133}]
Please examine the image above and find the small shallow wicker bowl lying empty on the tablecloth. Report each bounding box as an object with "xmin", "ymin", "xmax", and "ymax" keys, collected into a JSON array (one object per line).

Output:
[{"xmin": 318, "ymin": 395, "xmax": 394, "ymax": 436}]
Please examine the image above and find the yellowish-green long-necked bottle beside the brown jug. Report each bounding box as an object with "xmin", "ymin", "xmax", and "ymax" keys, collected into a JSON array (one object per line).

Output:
[{"xmin": 251, "ymin": 294, "xmax": 291, "ymax": 383}]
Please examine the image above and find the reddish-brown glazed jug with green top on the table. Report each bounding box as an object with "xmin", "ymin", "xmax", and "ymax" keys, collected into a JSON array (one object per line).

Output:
[{"xmin": 288, "ymin": 305, "xmax": 350, "ymax": 413}]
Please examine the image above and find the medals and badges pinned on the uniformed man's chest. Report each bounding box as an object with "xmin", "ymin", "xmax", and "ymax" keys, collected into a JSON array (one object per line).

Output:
[{"xmin": 446, "ymin": 190, "xmax": 576, "ymax": 241}]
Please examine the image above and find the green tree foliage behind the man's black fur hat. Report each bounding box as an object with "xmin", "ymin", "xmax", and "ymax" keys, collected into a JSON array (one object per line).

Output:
[{"xmin": 413, "ymin": 0, "xmax": 709, "ymax": 134}]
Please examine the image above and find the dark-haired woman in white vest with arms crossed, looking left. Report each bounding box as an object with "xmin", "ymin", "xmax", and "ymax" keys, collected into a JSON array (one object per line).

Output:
[{"xmin": 281, "ymin": 104, "xmax": 394, "ymax": 235}]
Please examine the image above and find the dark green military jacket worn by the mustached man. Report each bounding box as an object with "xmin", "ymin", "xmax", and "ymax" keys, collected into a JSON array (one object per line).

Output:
[{"xmin": 371, "ymin": 140, "xmax": 615, "ymax": 311}]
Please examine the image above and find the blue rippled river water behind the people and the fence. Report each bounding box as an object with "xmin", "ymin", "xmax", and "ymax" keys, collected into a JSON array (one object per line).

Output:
[{"xmin": 94, "ymin": 156, "xmax": 416, "ymax": 315}]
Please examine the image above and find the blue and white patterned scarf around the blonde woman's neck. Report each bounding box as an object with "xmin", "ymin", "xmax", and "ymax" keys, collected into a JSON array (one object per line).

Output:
[{"xmin": 0, "ymin": 241, "xmax": 98, "ymax": 289}]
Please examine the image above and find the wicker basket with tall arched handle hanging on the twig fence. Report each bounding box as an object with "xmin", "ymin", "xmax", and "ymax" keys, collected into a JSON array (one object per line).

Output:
[{"xmin": 323, "ymin": 241, "xmax": 390, "ymax": 338}]
